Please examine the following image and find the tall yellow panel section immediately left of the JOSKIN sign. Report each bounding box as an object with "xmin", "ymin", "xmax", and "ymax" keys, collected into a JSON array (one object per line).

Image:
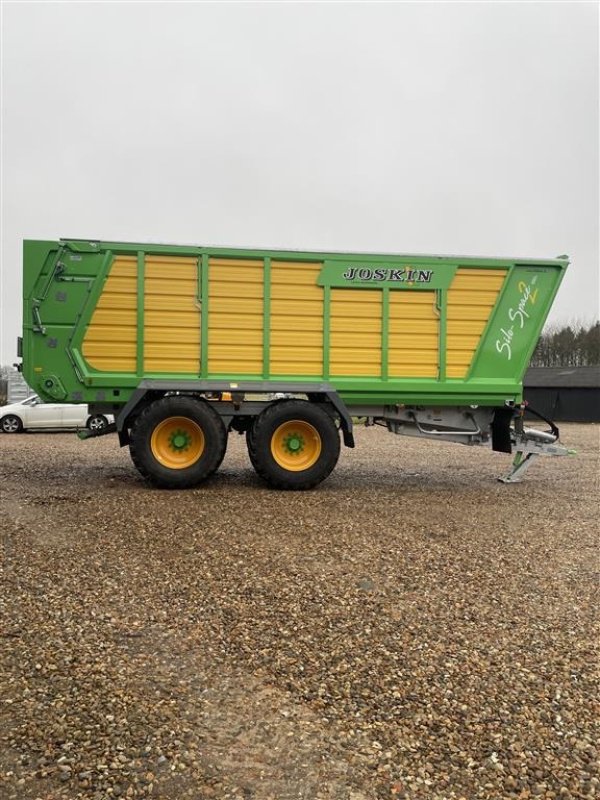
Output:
[{"xmin": 269, "ymin": 261, "xmax": 323, "ymax": 376}]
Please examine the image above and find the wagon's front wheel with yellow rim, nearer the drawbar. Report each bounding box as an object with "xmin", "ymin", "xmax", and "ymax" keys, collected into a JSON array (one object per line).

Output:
[{"xmin": 246, "ymin": 400, "xmax": 340, "ymax": 490}]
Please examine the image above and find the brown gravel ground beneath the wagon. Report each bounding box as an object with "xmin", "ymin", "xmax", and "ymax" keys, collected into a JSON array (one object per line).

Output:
[{"xmin": 0, "ymin": 425, "xmax": 600, "ymax": 800}]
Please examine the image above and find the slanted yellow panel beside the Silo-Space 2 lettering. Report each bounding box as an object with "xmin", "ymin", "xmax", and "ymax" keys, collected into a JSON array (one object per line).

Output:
[{"xmin": 446, "ymin": 267, "xmax": 506, "ymax": 378}]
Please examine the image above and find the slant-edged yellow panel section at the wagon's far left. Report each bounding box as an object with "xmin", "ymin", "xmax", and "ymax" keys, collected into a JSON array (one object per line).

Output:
[{"xmin": 81, "ymin": 256, "xmax": 137, "ymax": 372}]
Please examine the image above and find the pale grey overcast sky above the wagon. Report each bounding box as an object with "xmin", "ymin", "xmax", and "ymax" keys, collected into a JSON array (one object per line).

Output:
[{"xmin": 0, "ymin": 2, "xmax": 599, "ymax": 363}]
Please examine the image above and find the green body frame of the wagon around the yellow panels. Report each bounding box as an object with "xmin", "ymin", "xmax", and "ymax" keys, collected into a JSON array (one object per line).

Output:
[{"xmin": 23, "ymin": 240, "xmax": 568, "ymax": 409}]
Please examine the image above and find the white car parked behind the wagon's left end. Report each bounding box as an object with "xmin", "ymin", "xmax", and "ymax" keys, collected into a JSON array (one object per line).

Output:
[{"xmin": 0, "ymin": 394, "xmax": 113, "ymax": 433}]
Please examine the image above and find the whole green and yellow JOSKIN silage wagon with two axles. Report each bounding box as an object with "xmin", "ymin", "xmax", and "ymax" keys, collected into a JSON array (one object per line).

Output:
[{"xmin": 20, "ymin": 240, "xmax": 568, "ymax": 489}]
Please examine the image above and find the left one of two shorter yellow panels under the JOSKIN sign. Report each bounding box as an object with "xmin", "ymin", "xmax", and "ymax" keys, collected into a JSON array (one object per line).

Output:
[{"xmin": 329, "ymin": 289, "xmax": 383, "ymax": 377}]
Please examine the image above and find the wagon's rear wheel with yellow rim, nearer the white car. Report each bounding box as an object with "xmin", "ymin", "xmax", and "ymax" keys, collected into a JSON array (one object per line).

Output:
[{"xmin": 129, "ymin": 396, "xmax": 227, "ymax": 489}]
